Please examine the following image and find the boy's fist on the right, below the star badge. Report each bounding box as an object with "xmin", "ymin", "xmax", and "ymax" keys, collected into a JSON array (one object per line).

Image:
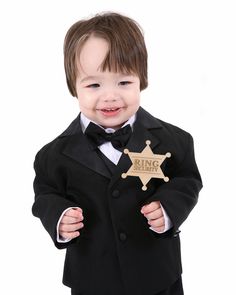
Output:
[{"xmin": 141, "ymin": 201, "xmax": 165, "ymax": 233}]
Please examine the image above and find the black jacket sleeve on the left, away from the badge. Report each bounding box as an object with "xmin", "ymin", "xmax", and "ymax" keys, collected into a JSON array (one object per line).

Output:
[{"xmin": 32, "ymin": 150, "xmax": 78, "ymax": 249}]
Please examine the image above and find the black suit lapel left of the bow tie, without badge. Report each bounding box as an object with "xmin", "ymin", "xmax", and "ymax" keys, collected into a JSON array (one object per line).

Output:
[{"xmin": 60, "ymin": 116, "xmax": 111, "ymax": 178}]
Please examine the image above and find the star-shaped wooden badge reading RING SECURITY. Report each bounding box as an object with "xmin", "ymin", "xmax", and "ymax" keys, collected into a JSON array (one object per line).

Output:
[{"xmin": 121, "ymin": 140, "xmax": 171, "ymax": 191}]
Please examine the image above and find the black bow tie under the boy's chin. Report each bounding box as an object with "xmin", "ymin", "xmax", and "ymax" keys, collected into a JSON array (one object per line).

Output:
[{"xmin": 85, "ymin": 122, "xmax": 132, "ymax": 149}]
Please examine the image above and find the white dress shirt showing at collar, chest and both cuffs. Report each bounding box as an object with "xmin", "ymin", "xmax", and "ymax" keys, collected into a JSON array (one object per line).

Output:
[{"xmin": 57, "ymin": 113, "xmax": 172, "ymax": 243}]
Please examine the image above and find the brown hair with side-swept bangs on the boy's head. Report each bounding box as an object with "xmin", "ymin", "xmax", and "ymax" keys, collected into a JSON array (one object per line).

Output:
[{"xmin": 64, "ymin": 13, "xmax": 148, "ymax": 96}]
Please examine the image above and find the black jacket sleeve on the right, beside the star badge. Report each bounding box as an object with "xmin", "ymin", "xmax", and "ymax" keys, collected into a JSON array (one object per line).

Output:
[{"xmin": 148, "ymin": 134, "xmax": 202, "ymax": 231}]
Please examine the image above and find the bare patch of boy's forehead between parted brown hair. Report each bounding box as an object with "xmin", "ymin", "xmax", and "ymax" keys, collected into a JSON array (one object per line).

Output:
[{"xmin": 77, "ymin": 36, "xmax": 109, "ymax": 74}]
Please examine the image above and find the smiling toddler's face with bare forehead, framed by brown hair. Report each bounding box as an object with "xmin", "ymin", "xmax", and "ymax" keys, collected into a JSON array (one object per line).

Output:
[{"xmin": 76, "ymin": 36, "xmax": 140, "ymax": 129}]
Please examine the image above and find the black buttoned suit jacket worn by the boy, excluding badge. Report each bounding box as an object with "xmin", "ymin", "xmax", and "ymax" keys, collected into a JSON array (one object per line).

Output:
[{"xmin": 33, "ymin": 108, "xmax": 202, "ymax": 295}]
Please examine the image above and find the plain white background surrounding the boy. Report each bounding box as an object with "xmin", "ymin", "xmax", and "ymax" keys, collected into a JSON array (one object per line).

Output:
[{"xmin": 0, "ymin": 0, "xmax": 236, "ymax": 295}]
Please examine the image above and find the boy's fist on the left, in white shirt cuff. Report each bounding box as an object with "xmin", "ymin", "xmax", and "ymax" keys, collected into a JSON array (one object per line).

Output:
[{"xmin": 59, "ymin": 208, "xmax": 84, "ymax": 239}]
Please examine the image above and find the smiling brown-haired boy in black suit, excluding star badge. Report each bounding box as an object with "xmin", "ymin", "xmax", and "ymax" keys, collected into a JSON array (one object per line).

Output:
[{"xmin": 33, "ymin": 13, "xmax": 202, "ymax": 295}]
